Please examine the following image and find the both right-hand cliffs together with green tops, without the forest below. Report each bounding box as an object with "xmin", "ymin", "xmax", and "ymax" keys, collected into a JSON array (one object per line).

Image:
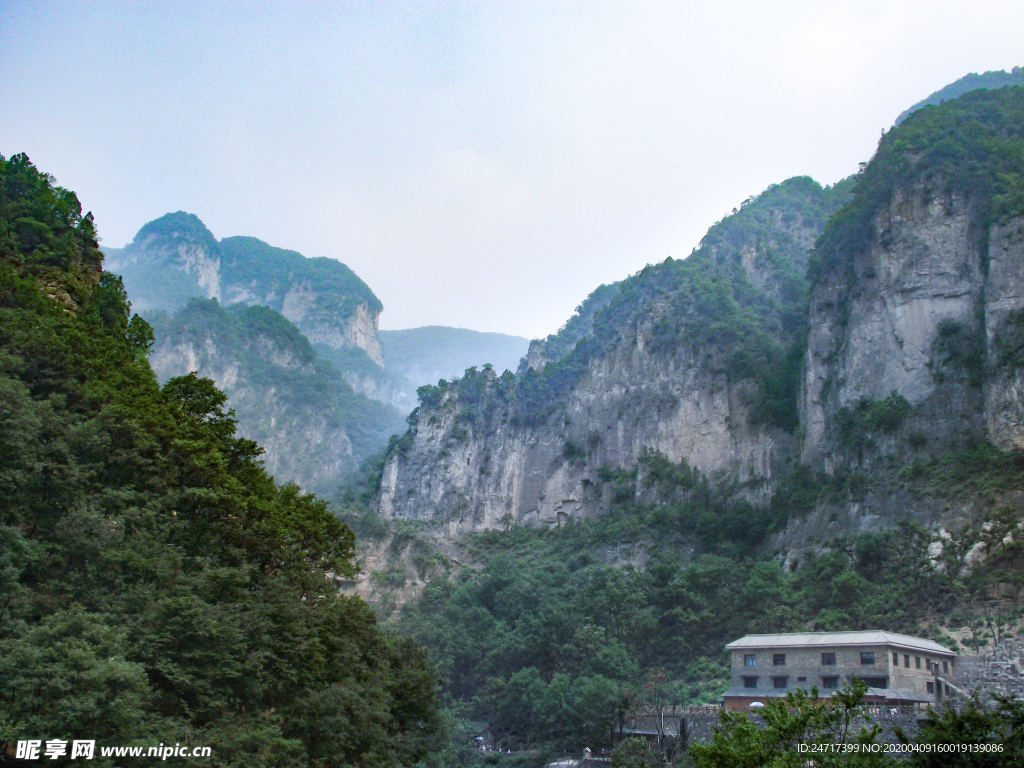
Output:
[{"xmin": 380, "ymin": 88, "xmax": 1024, "ymax": 554}]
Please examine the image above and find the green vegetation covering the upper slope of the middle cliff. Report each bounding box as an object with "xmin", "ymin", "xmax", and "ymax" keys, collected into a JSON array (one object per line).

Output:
[{"xmin": 505, "ymin": 177, "xmax": 846, "ymax": 430}]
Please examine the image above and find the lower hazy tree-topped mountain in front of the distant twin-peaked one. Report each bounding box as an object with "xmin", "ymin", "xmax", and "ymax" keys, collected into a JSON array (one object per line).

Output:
[{"xmin": 150, "ymin": 298, "xmax": 404, "ymax": 498}]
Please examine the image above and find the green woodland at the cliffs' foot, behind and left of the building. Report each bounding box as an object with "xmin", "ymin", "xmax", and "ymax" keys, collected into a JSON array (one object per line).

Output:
[{"xmin": 399, "ymin": 499, "xmax": 955, "ymax": 749}]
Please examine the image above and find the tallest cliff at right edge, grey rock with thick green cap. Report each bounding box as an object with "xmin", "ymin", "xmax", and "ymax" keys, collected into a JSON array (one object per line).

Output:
[{"xmin": 791, "ymin": 88, "xmax": 1024, "ymax": 538}]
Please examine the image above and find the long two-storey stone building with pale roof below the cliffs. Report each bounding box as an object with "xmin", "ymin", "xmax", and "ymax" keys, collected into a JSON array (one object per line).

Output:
[{"xmin": 723, "ymin": 630, "xmax": 956, "ymax": 709}]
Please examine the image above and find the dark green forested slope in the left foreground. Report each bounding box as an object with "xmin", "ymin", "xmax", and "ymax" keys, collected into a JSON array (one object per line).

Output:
[{"xmin": 0, "ymin": 155, "xmax": 442, "ymax": 768}]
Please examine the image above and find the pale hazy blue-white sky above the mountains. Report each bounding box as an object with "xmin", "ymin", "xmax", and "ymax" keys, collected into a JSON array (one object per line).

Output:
[{"xmin": 0, "ymin": 0, "xmax": 1024, "ymax": 337}]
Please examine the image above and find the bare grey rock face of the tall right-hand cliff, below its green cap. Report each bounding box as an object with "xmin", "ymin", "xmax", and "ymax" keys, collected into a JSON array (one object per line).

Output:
[{"xmin": 801, "ymin": 179, "xmax": 1024, "ymax": 469}]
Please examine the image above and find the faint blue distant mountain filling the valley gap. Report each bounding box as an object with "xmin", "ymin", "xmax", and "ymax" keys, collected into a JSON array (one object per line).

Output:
[{"xmin": 377, "ymin": 326, "xmax": 529, "ymax": 386}]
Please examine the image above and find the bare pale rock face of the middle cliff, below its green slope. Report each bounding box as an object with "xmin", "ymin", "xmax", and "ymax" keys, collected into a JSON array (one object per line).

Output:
[{"xmin": 380, "ymin": 327, "xmax": 794, "ymax": 532}]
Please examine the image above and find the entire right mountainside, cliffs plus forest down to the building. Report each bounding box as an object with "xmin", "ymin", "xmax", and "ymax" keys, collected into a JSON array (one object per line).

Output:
[{"xmin": 353, "ymin": 83, "xmax": 1024, "ymax": 765}]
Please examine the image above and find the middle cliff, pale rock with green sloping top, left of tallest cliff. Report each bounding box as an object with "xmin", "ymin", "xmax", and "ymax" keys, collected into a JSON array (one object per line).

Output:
[{"xmin": 380, "ymin": 178, "xmax": 845, "ymax": 529}]
